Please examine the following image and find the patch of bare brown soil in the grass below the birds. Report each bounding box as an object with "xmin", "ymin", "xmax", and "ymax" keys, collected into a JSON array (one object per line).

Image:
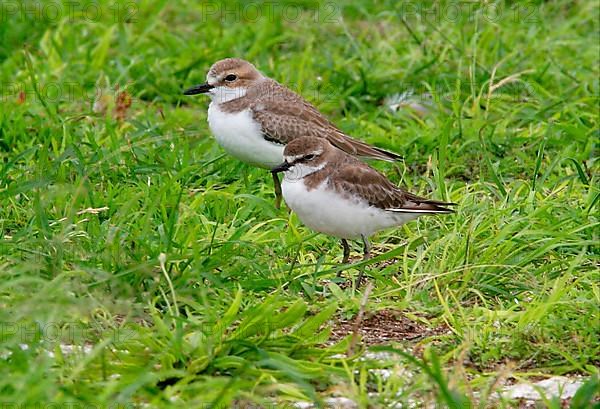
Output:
[{"xmin": 331, "ymin": 309, "xmax": 447, "ymax": 345}]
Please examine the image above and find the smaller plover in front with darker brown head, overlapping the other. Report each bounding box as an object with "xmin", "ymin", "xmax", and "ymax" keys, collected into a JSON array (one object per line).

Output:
[{"xmin": 272, "ymin": 136, "xmax": 454, "ymax": 283}]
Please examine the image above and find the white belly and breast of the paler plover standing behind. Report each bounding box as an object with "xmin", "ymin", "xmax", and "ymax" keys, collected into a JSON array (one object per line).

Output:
[{"xmin": 208, "ymin": 102, "xmax": 284, "ymax": 169}]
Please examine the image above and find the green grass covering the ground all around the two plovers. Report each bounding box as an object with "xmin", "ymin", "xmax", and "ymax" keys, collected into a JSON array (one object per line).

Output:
[{"xmin": 0, "ymin": 0, "xmax": 600, "ymax": 408}]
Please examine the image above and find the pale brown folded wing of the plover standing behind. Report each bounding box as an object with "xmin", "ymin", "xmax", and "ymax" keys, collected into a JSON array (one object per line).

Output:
[{"xmin": 251, "ymin": 81, "xmax": 402, "ymax": 161}]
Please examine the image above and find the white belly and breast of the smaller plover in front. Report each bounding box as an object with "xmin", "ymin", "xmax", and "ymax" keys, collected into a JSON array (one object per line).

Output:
[{"xmin": 281, "ymin": 179, "xmax": 417, "ymax": 239}]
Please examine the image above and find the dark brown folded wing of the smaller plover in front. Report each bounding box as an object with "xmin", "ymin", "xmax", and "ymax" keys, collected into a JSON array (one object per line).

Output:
[{"xmin": 329, "ymin": 162, "xmax": 453, "ymax": 213}]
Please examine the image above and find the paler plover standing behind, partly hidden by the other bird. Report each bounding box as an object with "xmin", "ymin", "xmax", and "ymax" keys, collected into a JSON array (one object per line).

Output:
[{"xmin": 184, "ymin": 58, "xmax": 401, "ymax": 207}]
